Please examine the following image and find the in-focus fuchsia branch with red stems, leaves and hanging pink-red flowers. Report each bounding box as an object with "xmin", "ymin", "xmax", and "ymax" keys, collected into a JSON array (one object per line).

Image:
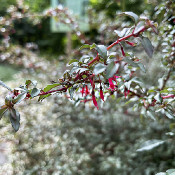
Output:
[{"xmin": 0, "ymin": 12, "xmax": 175, "ymax": 131}]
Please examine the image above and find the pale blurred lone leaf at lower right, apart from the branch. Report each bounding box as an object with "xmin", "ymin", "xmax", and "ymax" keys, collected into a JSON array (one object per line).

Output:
[{"xmin": 137, "ymin": 139, "xmax": 165, "ymax": 152}]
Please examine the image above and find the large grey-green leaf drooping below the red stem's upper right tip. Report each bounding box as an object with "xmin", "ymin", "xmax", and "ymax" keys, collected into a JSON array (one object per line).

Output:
[{"xmin": 141, "ymin": 37, "xmax": 154, "ymax": 58}]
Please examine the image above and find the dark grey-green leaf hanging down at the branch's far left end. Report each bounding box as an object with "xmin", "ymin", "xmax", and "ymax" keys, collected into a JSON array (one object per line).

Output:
[{"xmin": 10, "ymin": 108, "xmax": 20, "ymax": 132}]
